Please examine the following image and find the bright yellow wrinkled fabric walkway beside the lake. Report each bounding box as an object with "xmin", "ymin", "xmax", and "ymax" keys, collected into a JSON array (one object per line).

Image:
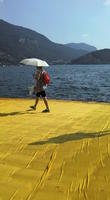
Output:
[{"xmin": 0, "ymin": 99, "xmax": 110, "ymax": 200}]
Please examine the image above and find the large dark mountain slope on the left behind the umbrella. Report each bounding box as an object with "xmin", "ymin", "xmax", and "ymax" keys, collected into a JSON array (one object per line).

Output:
[{"xmin": 0, "ymin": 20, "xmax": 87, "ymax": 64}]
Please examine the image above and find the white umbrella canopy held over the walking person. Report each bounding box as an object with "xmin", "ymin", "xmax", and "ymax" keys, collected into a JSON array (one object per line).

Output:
[{"xmin": 20, "ymin": 58, "xmax": 49, "ymax": 67}]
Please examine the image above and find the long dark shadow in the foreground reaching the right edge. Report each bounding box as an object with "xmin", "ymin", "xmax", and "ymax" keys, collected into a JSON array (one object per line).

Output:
[{"xmin": 29, "ymin": 130, "xmax": 110, "ymax": 145}]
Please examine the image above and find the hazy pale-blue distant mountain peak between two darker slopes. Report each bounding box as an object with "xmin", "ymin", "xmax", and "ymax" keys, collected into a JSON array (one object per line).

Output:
[{"xmin": 65, "ymin": 43, "xmax": 97, "ymax": 52}]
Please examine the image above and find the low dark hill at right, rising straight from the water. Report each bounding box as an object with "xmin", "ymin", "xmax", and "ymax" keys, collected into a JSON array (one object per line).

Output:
[{"xmin": 71, "ymin": 49, "xmax": 110, "ymax": 64}]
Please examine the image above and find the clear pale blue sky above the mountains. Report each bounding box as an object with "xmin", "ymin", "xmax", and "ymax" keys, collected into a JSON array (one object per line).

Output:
[{"xmin": 0, "ymin": 0, "xmax": 110, "ymax": 49}]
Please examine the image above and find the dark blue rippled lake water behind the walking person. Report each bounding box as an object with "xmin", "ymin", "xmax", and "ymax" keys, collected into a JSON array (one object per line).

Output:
[{"xmin": 0, "ymin": 65, "xmax": 110, "ymax": 102}]
